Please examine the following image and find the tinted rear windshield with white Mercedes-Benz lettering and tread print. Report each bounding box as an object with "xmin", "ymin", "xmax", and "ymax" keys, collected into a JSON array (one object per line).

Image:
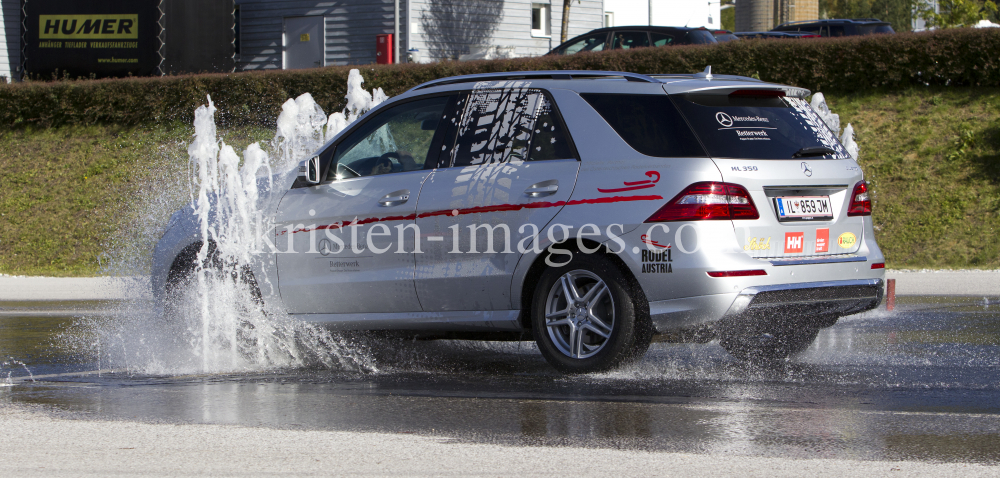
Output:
[{"xmin": 670, "ymin": 94, "xmax": 850, "ymax": 159}]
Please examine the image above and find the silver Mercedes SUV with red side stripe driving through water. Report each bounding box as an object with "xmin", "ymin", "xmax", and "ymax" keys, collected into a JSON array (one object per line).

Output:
[{"xmin": 153, "ymin": 70, "xmax": 884, "ymax": 372}]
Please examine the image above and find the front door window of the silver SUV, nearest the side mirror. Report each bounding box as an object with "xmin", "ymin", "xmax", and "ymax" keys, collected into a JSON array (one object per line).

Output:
[{"xmin": 327, "ymin": 96, "xmax": 448, "ymax": 180}]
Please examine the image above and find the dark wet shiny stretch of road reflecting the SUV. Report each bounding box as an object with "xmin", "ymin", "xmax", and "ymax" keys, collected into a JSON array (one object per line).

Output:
[{"xmin": 0, "ymin": 297, "xmax": 1000, "ymax": 464}]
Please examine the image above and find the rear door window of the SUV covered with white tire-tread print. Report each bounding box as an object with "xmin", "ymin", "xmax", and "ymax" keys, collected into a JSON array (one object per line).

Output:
[{"xmin": 450, "ymin": 87, "xmax": 575, "ymax": 167}]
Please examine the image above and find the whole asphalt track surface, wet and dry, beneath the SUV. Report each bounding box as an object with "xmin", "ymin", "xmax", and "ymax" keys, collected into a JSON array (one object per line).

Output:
[{"xmin": 0, "ymin": 272, "xmax": 1000, "ymax": 476}]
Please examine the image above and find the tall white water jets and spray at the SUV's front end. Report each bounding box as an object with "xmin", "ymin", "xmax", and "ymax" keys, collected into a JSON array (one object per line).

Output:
[{"xmin": 62, "ymin": 70, "xmax": 385, "ymax": 374}]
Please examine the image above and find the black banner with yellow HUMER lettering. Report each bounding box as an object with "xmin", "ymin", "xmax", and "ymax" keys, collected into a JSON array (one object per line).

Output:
[{"xmin": 24, "ymin": 0, "xmax": 161, "ymax": 78}]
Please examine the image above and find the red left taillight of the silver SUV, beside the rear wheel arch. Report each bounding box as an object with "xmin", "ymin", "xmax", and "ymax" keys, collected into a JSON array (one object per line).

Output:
[{"xmin": 646, "ymin": 182, "xmax": 760, "ymax": 222}]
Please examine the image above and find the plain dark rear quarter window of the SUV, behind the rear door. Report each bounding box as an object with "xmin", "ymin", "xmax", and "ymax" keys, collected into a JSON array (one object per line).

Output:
[{"xmin": 580, "ymin": 93, "xmax": 705, "ymax": 158}]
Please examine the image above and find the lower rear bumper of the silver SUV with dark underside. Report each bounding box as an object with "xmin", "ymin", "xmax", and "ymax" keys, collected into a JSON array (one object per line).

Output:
[{"xmin": 649, "ymin": 279, "xmax": 884, "ymax": 334}]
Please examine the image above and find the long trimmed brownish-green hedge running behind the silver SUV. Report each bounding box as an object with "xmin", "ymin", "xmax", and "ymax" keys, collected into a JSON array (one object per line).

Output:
[{"xmin": 0, "ymin": 28, "xmax": 1000, "ymax": 127}]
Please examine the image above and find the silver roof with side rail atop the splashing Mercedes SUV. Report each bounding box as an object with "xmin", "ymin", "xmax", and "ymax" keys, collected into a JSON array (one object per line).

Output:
[{"xmin": 407, "ymin": 67, "xmax": 810, "ymax": 98}]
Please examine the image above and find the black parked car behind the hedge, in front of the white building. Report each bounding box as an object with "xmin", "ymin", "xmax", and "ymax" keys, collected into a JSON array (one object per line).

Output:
[{"xmin": 547, "ymin": 26, "xmax": 718, "ymax": 55}]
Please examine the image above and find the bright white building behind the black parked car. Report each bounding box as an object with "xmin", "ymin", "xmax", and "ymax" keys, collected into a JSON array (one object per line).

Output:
[{"xmin": 600, "ymin": 0, "xmax": 722, "ymax": 29}]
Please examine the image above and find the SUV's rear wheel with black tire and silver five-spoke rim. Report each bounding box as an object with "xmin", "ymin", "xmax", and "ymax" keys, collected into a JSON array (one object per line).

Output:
[{"xmin": 531, "ymin": 253, "xmax": 653, "ymax": 373}]
